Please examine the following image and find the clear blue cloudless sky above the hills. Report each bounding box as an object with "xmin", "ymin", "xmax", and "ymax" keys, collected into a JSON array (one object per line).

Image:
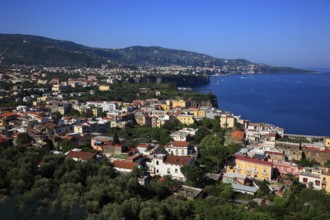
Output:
[{"xmin": 0, "ymin": 0, "xmax": 330, "ymax": 67}]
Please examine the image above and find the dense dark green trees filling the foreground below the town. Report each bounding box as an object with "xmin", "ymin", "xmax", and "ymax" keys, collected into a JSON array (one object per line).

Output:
[{"xmin": 0, "ymin": 144, "xmax": 330, "ymax": 220}]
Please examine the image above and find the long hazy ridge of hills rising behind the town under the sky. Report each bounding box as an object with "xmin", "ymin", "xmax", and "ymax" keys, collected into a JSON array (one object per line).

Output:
[{"xmin": 0, "ymin": 34, "xmax": 310, "ymax": 73}]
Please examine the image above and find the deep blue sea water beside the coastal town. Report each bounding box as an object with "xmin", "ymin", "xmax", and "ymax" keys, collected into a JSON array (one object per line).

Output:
[{"xmin": 195, "ymin": 71, "xmax": 330, "ymax": 136}]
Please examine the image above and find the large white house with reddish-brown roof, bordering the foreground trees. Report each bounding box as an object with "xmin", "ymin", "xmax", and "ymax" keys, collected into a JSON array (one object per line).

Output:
[{"xmin": 147, "ymin": 154, "xmax": 194, "ymax": 180}]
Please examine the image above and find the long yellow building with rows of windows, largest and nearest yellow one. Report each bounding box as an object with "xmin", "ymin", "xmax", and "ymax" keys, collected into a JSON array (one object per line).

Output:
[{"xmin": 226, "ymin": 155, "xmax": 273, "ymax": 180}]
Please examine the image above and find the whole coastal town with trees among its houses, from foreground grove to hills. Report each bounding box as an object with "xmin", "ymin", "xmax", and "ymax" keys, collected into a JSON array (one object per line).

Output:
[{"xmin": 0, "ymin": 65, "xmax": 330, "ymax": 218}]
